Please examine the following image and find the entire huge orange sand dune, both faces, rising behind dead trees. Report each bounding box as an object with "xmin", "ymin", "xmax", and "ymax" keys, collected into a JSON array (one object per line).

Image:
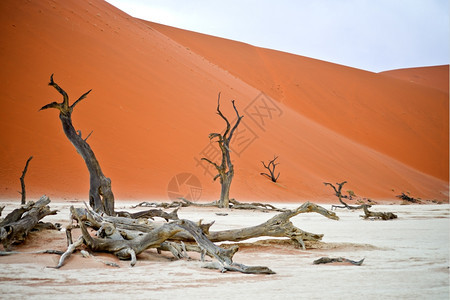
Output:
[{"xmin": 0, "ymin": 0, "xmax": 448, "ymax": 202}]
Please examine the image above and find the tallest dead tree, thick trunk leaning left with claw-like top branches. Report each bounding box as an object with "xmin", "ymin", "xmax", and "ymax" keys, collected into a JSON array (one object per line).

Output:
[{"xmin": 40, "ymin": 74, "xmax": 114, "ymax": 215}]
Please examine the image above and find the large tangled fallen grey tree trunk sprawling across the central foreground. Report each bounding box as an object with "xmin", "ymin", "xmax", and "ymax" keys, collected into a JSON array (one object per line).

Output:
[{"xmin": 57, "ymin": 202, "xmax": 338, "ymax": 274}]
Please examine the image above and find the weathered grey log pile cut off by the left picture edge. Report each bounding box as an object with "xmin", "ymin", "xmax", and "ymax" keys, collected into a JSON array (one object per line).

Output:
[{"xmin": 0, "ymin": 196, "xmax": 57, "ymax": 250}]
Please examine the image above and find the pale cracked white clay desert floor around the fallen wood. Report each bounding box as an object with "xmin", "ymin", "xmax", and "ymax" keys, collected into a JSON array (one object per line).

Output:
[{"xmin": 0, "ymin": 202, "xmax": 450, "ymax": 299}]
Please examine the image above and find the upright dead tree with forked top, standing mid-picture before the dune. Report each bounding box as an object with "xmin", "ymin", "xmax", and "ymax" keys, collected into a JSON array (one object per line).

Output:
[{"xmin": 202, "ymin": 93, "xmax": 243, "ymax": 208}]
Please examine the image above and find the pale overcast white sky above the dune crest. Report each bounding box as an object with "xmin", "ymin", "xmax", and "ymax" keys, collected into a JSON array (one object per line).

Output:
[{"xmin": 107, "ymin": 0, "xmax": 450, "ymax": 72}]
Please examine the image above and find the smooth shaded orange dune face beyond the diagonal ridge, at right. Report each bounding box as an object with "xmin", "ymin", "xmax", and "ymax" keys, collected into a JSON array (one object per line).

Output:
[{"xmin": 149, "ymin": 23, "xmax": 449, "ymax": 181}]
